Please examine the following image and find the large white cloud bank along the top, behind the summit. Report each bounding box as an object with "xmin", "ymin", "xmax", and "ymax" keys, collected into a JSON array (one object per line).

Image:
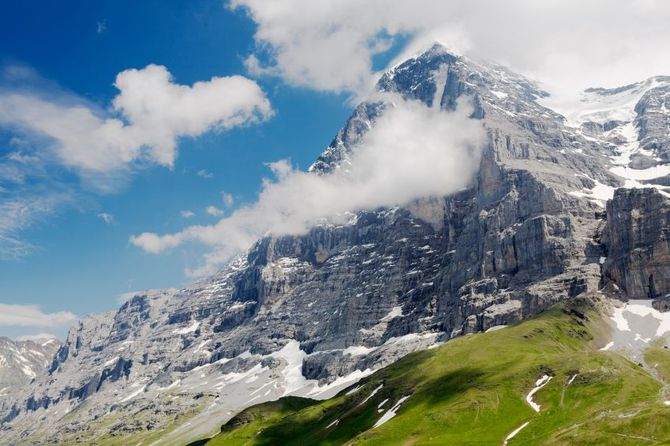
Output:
[{"xmin": 234, "ymin": 0, "xmax": 670, "ymax": 97}]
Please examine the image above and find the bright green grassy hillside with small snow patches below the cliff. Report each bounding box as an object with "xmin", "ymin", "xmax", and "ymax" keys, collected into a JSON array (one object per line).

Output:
[{"xmin": 192, "ymin": 303, "xmax": 670, "ymax": 446}]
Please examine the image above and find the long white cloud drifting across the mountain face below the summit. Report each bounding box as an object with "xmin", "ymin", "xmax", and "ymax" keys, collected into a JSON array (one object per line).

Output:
[{"xmin": 131, "ymin": 96, "xmax": 485, "ymax": 273}]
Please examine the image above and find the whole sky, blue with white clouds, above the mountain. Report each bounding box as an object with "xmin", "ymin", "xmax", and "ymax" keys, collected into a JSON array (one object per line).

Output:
[{"xmin": 0, "ymin": 0, "xmax": 670, "ymax": 337}]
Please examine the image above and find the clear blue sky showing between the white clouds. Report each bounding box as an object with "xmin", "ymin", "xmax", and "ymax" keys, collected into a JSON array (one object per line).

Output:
[{"xmin": 0, "ymin": 0, "xmax": 350, "ymax": 336}]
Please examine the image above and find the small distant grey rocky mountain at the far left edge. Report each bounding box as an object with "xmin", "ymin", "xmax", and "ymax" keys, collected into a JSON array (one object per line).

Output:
[{"xmin": 0, "ymin": 337, "xmax": 60, "ymax": 397}]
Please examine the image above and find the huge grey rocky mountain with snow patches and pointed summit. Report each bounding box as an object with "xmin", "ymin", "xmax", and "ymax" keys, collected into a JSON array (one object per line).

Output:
[{"xmin": 0, "ymin": 45, "xmax": 670, "ymax": 444}]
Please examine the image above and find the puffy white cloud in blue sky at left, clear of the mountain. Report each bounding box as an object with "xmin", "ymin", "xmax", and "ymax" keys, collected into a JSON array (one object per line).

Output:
[{"xmin": 0, "ymin": 65, "xmax": 272, "ymax": 173}]
